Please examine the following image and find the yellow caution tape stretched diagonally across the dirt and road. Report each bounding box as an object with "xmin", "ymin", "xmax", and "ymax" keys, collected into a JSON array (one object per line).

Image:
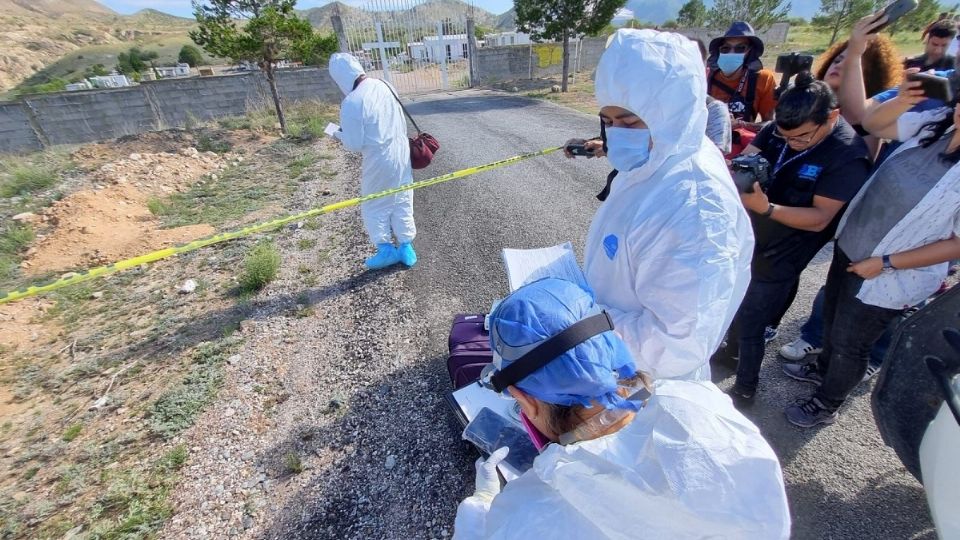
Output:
[{"xmin": 0, "ymin": 146, "xmax": 562, "ymax": 304}]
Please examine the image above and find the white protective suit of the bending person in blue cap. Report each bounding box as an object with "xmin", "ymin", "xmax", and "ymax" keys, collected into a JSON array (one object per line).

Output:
[{"xmin": 454, "ymin": 380, "xmax": 790, "ymax": 540}]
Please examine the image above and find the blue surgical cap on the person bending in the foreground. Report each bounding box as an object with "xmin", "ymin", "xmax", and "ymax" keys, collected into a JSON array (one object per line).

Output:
[{"xmin": 490, "ymin": 278, "xmax": 639, "ymax": 410}]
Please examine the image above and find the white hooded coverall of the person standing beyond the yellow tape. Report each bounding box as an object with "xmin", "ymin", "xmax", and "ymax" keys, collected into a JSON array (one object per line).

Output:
[{"xmin": 330, "ymin": 53, "xmax": 417, "ymax": 245}]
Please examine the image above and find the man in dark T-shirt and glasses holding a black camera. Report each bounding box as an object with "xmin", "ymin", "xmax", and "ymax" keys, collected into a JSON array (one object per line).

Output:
[{"xmin": 717, "ymin": 71, "xmax": 870, "ymax": 404}]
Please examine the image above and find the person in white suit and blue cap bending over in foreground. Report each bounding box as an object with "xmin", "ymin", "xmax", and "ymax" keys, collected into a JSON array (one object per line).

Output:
[{"xmin": 454, "ymin": 278, "xmax": 790, "ymax": 540}]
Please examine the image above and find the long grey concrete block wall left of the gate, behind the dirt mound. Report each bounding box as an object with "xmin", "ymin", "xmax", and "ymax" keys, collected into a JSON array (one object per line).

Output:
[{"xmin": 0, "ymin": 68, "xmax": 343, "ymax": 153}]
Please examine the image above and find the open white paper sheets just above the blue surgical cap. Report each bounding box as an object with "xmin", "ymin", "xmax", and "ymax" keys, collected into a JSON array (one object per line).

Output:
[{"xmin": 503, "ymin": 242, "xmax": 590, "ymax": 291}]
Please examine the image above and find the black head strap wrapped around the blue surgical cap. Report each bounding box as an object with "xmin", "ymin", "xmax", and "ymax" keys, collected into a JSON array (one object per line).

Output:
[{"xmin": 490, "ymin": 311, "xmax": 613, "ymax": 392}]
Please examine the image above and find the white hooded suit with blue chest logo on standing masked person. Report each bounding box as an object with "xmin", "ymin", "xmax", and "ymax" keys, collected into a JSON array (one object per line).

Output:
[{"xmin": 584, "ymin": 30, "xmax": 753, "ymax": 380}]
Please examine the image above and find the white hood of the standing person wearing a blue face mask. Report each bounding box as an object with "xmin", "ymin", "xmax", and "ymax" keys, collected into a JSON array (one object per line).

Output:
[{"xmin": 596, "ymin": 29, "xmax": 707, "ymax": 180}]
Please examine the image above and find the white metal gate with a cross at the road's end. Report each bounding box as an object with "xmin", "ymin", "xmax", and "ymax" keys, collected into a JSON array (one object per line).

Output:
[{"xmin": 341, "ymin": 0, "xmax": 470, "ymax": 94}]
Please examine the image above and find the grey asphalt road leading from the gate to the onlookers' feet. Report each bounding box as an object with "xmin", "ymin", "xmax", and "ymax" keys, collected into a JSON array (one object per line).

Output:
[{"xmin": 405, "ymin": 91, "xmax": 936, "ymax": 539}]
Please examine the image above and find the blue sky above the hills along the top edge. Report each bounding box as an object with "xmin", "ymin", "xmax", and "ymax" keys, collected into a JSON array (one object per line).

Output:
[{"xmin": 98, "ymin": 0, "xmax": 820, "ymax": 23}]
